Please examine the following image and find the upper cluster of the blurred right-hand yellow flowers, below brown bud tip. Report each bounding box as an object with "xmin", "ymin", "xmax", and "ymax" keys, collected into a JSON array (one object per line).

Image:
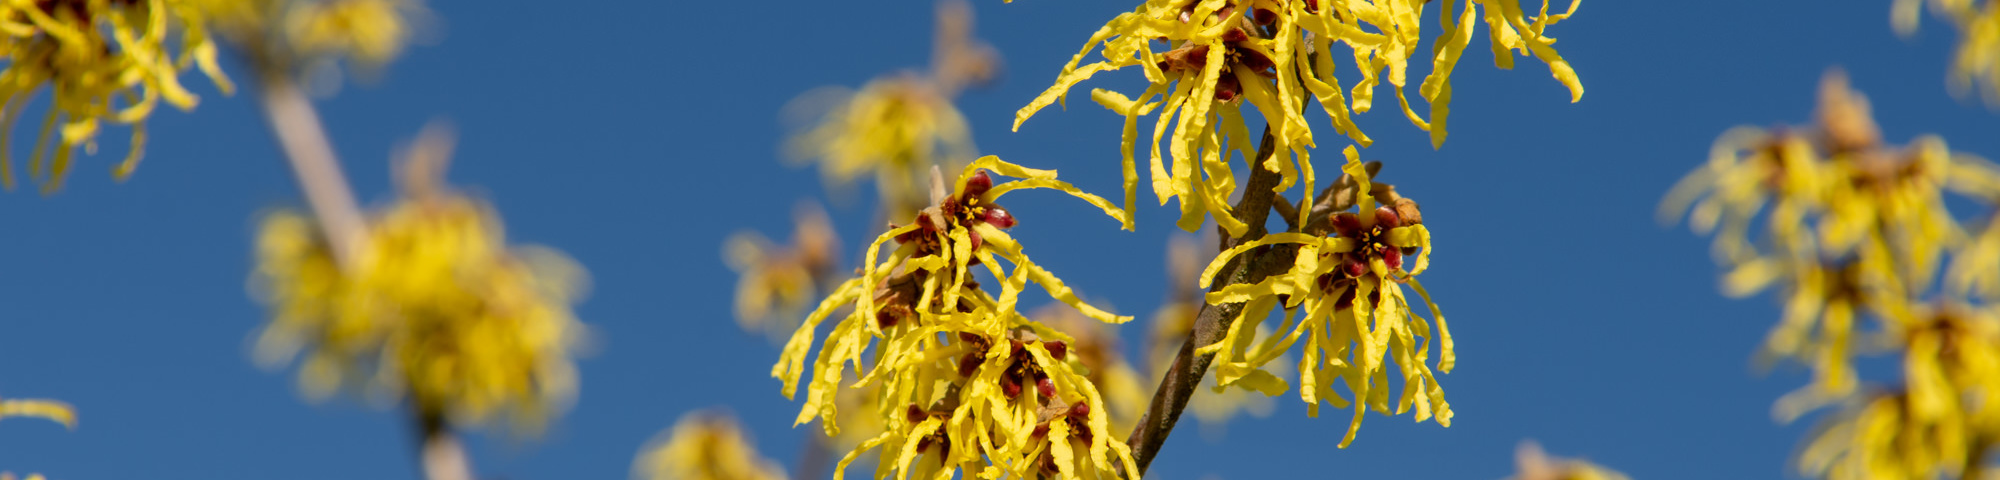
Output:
[{"xmin": 1660, "ymin": 72, "xmax": 2000, "ymax": 406}]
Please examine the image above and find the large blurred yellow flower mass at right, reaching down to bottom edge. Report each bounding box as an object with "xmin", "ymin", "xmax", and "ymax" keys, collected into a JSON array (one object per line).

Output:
[{"xmin": 1662, "ymin": 72, "xmax": 2000, "ymax": 478}]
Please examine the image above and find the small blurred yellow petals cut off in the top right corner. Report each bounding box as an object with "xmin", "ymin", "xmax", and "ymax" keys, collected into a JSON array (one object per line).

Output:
[{"xmin": 1890, "ymin": 0, "xmax": 2000, "ymax": 102}]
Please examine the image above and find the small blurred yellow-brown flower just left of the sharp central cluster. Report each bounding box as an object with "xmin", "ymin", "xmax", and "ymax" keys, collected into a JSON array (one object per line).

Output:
[{"xmin": 722, "ymin": 204, "xmax": 840, "ymax": 338}]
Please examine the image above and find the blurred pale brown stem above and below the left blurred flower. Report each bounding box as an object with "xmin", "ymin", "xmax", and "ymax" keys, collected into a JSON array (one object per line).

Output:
[{"xmin": 260, "ymin": 72, "xmax": 472, "ymax": 480}]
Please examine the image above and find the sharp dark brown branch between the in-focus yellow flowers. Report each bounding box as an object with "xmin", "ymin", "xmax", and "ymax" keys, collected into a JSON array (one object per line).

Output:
[{"xmin": 1126, "ymin": 128, "xmax": 1294, "ymax": 474}]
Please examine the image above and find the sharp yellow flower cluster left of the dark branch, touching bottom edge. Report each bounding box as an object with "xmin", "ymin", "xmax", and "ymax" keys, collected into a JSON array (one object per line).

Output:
[{"xmin": 772, "ymin": 156, "xmax": 1138, "ymax": 478}]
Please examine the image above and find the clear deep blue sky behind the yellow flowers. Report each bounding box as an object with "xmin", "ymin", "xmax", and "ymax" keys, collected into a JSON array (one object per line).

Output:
[{"xmin": 0, "ymin": 0, "xmax": 2000, "ymax": 480}]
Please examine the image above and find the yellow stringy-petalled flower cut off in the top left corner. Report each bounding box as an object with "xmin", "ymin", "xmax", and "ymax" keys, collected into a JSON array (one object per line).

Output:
[{"xmin": 0, "ymin": 0, "xmax": 232, "ymax": 192}]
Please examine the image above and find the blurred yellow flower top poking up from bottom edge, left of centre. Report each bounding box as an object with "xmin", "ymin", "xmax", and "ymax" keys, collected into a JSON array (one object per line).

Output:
[{"xmin": 632, "ymin": 412, "xmax": 786, "ymax": 480}]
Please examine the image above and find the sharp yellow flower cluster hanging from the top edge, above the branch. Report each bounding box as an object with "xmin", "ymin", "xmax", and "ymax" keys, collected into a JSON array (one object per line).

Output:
[{"xmin": 1014, "ymin": 0, "xmax": 1584, "ymax": 236}]
